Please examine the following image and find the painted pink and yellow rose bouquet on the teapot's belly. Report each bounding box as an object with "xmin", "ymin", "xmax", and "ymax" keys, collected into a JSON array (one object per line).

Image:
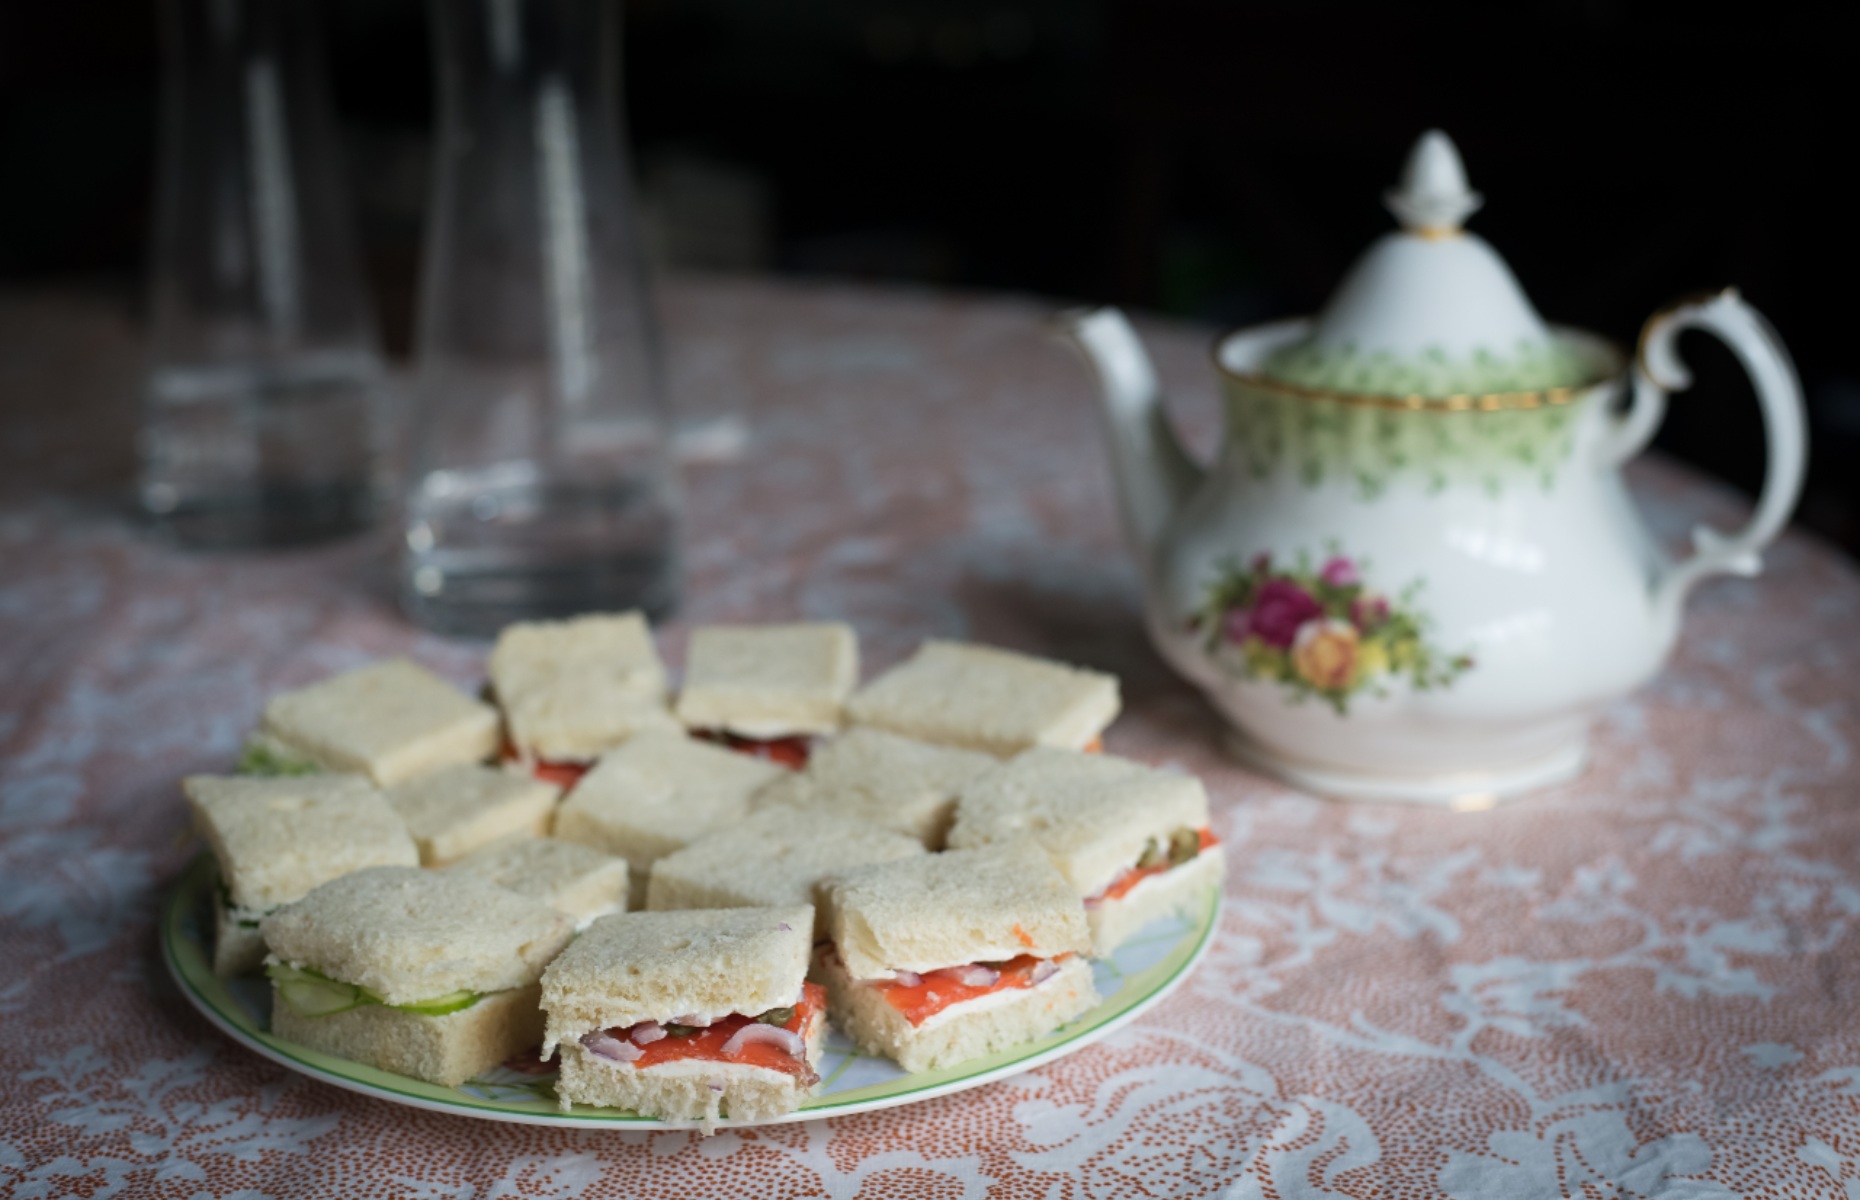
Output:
[{"xmin": 1189, "ymin": 547, "xmax": 1473, "ymax": 716}]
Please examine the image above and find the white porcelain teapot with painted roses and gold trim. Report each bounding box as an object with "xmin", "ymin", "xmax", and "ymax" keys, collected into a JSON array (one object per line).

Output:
[{"xmin": 1060, "ymin": 130, "xmax": 1806, "ymax": 807}]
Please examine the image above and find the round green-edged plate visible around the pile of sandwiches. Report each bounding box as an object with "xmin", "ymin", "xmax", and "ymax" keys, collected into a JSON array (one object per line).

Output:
[{"xmin": 162, "ymin": 856, "xmax": 1220, "ymax": 1129}]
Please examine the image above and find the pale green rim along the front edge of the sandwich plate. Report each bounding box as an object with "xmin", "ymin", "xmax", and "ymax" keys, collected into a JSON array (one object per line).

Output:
[{"xmin": 160, "ymin": 854, "xmax": 1220, "ymax": 1129}]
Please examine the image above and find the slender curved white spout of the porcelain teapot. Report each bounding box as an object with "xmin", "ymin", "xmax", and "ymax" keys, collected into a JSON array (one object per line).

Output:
[{"xmin": 1056, "ymin": 309, "xmax": 1203, "ymax": 554}]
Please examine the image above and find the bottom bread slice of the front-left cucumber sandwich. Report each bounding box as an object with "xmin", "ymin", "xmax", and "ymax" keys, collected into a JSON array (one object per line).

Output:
[{"xmin": 272, "ymin": 984, "xmax": 543, "ymax": 1088}]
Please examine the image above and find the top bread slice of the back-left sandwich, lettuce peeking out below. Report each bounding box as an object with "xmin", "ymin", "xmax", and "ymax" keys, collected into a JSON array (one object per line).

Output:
[{"xmin": 260, "ymin": 659, "xmax": 498, "ymax": 787}]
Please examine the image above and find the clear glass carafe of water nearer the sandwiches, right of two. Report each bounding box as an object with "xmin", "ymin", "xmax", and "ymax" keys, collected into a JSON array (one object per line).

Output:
[{"xmin": 402, "ymin": 0, "xmax": 679, "ymax": 634}]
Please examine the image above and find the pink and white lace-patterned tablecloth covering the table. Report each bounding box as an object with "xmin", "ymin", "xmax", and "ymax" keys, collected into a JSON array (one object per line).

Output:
[{"xmin": 0, "ymin": 281, "xmax": 1860, "ymax": 1200}]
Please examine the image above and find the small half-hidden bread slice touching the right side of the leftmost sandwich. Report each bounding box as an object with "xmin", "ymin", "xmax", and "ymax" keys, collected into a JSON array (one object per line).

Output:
[{"xmin": 387, "ymin": 763, "xmax": 562, "ymax": 867}]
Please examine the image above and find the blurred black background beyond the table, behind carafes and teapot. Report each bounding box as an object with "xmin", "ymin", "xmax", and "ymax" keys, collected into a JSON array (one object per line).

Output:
[{"xmin": 0, "ymin": 0, "xmax": 1860, "ymax": 551}]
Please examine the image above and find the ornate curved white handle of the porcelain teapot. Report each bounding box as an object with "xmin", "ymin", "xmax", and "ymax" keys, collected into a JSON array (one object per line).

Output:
[{"xmin": 1620, "ymin": 288, "xmax": 1808, "ymax": 618}]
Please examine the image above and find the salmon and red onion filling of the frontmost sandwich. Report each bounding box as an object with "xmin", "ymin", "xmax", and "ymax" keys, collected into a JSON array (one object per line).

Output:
[{"xmin": 580, "ymin": 982, "xmax": 826, "ymax": 1083}]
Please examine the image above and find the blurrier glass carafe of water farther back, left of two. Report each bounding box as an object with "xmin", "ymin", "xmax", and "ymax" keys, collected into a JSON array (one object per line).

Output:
[{"xmin": 138, "ymin": 0, "xmax": 387, "ymax": 545}]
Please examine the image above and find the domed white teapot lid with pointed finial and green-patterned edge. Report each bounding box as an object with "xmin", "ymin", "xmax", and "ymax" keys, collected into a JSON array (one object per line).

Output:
[{"xmin": 1259, "ymin": 128, "xmax": 1594, "ymax": 396}]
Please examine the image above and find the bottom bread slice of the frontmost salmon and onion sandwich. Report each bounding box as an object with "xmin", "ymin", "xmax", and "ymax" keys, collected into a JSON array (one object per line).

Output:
[{"xmin": 556, "ymin": 1016, "xmax": 826, "ymax": 1133}]
